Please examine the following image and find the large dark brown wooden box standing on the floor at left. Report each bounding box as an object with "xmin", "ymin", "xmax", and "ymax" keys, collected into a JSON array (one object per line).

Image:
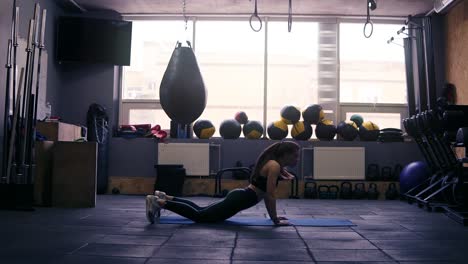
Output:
[{"xmin": 52, "ymin": 141, "xmax": 97, "ymax": 207}]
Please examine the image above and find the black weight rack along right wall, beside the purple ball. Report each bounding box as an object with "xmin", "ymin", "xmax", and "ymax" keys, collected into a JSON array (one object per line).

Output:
[{"xmin": 403, "ymin": 105, "xmax": 468, "ymax": 225}]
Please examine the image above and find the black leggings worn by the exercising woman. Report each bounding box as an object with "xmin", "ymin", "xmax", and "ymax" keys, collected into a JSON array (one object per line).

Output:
[{"xmin": 164, "ymin": 188, "xmax": 258, "ymax": 223}]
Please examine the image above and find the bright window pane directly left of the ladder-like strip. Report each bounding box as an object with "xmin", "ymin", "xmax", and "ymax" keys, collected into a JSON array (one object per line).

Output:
[{"xmin": 267, "ymin": 21, "xmax": 318, "ymax": 125}]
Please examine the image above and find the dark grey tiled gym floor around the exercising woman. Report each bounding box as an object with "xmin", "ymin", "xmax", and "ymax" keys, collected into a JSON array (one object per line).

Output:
[{"xmin": 0, "ymin": 195, "xmax": 468, "ymax": 264}]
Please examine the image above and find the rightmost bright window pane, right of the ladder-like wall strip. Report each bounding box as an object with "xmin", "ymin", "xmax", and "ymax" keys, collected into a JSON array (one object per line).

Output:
[{"xmin": 339, "ymin": 23, "xmax": 408, "ymax": 128}]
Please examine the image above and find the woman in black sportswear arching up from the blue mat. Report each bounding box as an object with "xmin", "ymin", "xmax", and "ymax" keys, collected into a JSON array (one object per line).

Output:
[{"xmin": 146, "ymin": 141, "xmax": 300, "ymax": 225}]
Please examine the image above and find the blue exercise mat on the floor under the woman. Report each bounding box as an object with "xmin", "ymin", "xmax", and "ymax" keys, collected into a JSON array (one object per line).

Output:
[{"xmin": 159, "ymin": 216, "xmax": 354, "ymax": 226}]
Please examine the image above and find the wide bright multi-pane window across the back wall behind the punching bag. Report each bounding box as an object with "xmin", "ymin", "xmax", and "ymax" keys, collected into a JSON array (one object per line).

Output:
[{"xmin": 120, "ymin": 17, "xmax": 407, "ymax": 136}]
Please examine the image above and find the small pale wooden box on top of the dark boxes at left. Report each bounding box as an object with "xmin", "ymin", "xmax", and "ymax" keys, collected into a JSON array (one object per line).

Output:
[{"xmin": 36, "ymin": 122, "xmax": 81, "ymax": 141}]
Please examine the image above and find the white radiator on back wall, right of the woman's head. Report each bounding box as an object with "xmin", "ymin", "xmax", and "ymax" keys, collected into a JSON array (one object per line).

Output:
[{"xmin": 313, "ymin": 147, "xmax": 366, "ymax": 180}]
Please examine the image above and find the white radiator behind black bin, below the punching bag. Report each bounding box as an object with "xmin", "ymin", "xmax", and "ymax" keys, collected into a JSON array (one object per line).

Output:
[{"xmin": 158, "ymin": 143, "xmax": 210, "ymax": 176}]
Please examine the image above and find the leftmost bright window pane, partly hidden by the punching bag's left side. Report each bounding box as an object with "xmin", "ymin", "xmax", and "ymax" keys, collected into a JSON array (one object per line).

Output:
[{"xmin": 120, "ymin": 20, "xmax": 193, "ymax": 128}]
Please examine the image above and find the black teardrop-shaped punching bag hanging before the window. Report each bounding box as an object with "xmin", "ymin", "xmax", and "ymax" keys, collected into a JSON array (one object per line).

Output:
[{"xmin": 159, "ymin": 41, "xmax": 206, "ymax": 124}]
